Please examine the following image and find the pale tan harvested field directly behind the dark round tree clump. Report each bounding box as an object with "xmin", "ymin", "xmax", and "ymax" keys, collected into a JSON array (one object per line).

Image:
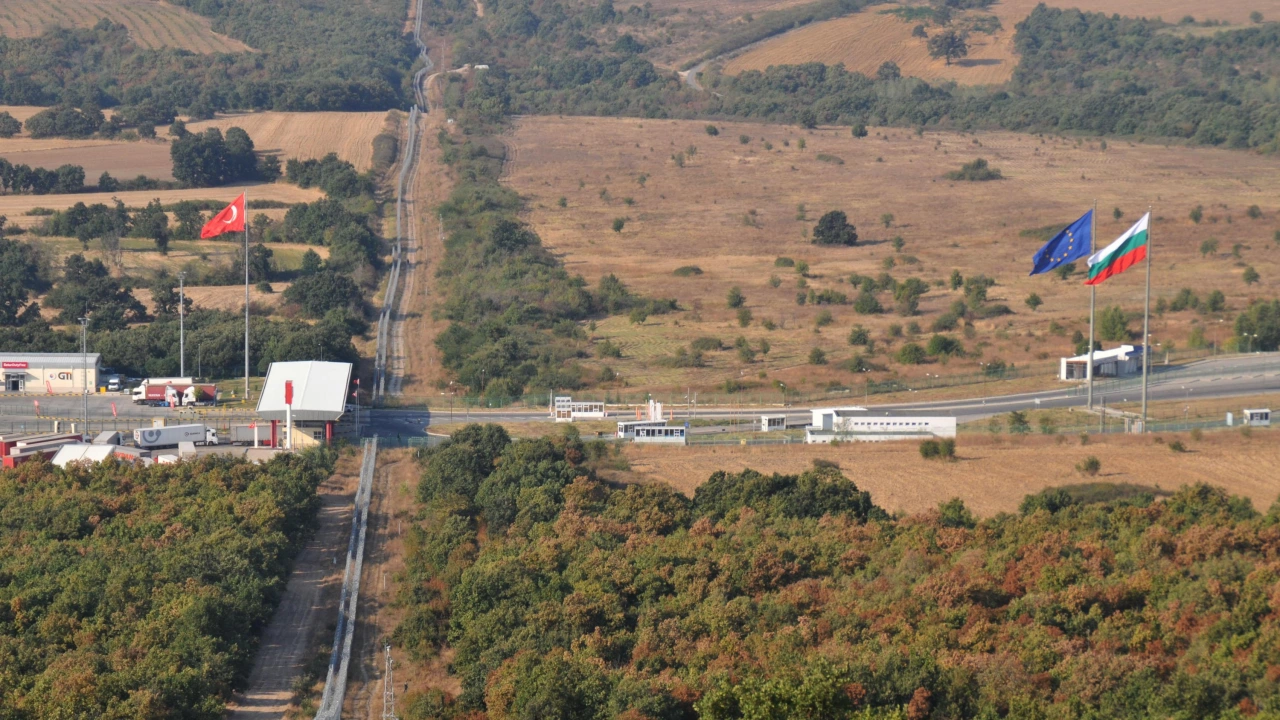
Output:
[{"xmin": 187, "ymin": 113, "xmax": 387, "ymax": 172}]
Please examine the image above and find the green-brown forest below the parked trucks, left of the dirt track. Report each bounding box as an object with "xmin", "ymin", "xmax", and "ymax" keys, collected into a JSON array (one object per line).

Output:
[{"xmin": 0, "ymin": 450, "xmax": 335, "ymax": 720}]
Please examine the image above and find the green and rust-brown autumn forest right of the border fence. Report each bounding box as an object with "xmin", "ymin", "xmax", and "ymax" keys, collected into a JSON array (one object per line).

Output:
[{"xmin": 396, "ymin": 425, "xmax": 1280, "ymax": 720}]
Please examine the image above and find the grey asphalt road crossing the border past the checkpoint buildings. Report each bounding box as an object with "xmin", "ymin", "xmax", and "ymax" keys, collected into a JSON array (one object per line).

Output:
[{"xmin": 0, "ymin": 352, "xmax": 1280, "ymax": 437}]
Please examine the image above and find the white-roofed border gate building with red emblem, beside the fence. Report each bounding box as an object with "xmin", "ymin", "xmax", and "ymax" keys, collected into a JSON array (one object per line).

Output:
[{"xmin": 257, "ymin": 360, "xmax": 351, "ymax": 448}]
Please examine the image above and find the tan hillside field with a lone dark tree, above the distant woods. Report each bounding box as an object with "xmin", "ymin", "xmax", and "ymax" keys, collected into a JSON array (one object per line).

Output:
[{"xmin": 723, "ymin": 5, "xmax": 1020, "ymax": 85}]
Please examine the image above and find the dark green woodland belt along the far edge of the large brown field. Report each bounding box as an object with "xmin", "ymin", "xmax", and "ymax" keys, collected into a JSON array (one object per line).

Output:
[{"xmin": 429, "ymin": 0, "xmax": 1280, "ymax": 150}]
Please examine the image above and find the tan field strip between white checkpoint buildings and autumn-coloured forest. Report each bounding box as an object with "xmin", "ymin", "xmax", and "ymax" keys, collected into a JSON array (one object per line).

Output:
[{"xmin": 618, "ymin": 430, "xmax": 1280, "ymax": 516}]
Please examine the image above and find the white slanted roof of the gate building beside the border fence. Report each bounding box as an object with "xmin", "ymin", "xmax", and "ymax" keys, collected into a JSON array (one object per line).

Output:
[{"xmin": 257, "ymin": 360, "xmax": 351, "ymax": 421}]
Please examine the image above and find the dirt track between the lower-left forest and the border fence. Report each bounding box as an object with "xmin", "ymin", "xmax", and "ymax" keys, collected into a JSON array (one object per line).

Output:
[{"xmin": 227, "ymin": 452, "xmax": 360, "ymax": 720}]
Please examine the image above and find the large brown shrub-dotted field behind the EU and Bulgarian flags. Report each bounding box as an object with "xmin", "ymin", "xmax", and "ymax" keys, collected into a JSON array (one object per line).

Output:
[{"xmin": 506, "ymin": 118, "xmax": 1280, "ymax": 391}]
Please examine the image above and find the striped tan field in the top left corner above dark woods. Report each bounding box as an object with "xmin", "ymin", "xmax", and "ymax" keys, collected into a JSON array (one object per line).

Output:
[{"xmin": 0, "ymin": 0, "xmax": 252, "ymax": 54}]
